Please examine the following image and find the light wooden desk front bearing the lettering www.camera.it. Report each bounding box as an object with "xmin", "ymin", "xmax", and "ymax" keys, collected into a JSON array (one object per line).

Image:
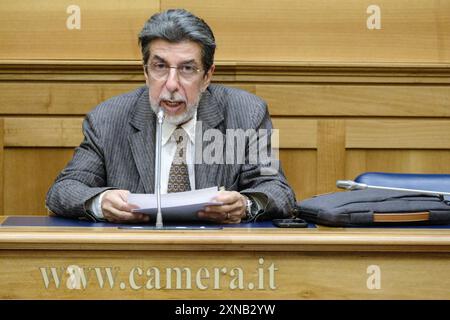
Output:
[{"xmin": 0, "ymin": 218, "xmax": 450, "ymax": 299}]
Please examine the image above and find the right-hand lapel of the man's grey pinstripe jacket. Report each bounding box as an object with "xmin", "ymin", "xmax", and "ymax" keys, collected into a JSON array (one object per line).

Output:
[{"xmin": 195, "ymin": 90, "xmax": 225, "ymax": 189}]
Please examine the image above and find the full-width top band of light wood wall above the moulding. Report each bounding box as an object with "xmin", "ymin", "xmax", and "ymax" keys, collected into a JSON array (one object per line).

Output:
[{"xmin": 0, "ymin": 0, "xmax": 450, "ymax": 63}]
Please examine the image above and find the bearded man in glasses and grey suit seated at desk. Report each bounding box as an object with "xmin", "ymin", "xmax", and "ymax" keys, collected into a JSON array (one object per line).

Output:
[{"xmin": 46, "ymin": 9, "xmax": 295, "ymax": 223}]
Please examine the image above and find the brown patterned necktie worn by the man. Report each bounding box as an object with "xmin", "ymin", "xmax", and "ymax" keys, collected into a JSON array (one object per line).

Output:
[{"xmin": 167, "ymin": 127, "xmax": 191, "ymax": 193}]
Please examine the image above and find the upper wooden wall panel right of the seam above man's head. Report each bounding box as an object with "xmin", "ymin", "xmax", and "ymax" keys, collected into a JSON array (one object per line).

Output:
[{"xmin": 161, "ymin": 0, "xmax": 450, "ymax": 62}]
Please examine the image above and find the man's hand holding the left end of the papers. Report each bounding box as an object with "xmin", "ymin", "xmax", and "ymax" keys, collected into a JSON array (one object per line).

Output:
[{"xmin": 101, "ymin": 190, "xmax": 150, "ymax": 223}]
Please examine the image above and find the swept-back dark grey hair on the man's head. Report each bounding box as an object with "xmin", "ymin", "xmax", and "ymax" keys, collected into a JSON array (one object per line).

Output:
[{"xmin": 139, "ymin": 9, "xmax": 216, "ymax": 73}]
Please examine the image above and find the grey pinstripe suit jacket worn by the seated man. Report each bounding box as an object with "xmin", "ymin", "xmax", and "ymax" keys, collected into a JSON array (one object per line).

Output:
[{"xmin": 46, "ymin": 85, "xmax": 295, "ymax": 218}]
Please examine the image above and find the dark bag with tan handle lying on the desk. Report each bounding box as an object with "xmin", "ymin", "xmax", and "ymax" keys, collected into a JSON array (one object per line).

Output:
[{"xmin": 296, "ymin": 189, "xmax": 450, "ymax": 227}]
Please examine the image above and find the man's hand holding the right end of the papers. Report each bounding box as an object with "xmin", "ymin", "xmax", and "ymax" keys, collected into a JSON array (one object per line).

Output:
[{"xmin": 198, "ymin": 191, "xmax": 247, "ymax": 223}]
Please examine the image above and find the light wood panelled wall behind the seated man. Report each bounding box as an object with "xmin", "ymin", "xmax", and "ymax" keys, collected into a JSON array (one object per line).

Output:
[{"xmin": 0, "ymin": 0, "xmax": 450, "ymax": 215}]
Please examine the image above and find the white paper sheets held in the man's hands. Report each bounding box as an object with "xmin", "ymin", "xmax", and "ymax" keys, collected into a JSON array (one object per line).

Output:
[{"xmin": 128, "ymin": 187, "xmax": 222, "ymax": 221}]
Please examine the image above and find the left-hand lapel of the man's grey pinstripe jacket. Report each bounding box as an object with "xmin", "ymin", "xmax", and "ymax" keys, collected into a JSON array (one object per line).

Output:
[{"xmin": 128, "ymin": 89, "xmax": 156, "ymax": 193}]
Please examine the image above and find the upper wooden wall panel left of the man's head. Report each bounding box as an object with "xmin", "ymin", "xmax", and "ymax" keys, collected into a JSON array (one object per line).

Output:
[{"xmin": 0, "ymin": 0, "xmax": 159, "ymax": 60}]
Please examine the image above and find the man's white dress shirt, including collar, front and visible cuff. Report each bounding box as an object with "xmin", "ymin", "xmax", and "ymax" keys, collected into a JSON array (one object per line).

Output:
[{"xmin": 86, "ymin": 113, "xmax": 197, "ymax": 219}]
